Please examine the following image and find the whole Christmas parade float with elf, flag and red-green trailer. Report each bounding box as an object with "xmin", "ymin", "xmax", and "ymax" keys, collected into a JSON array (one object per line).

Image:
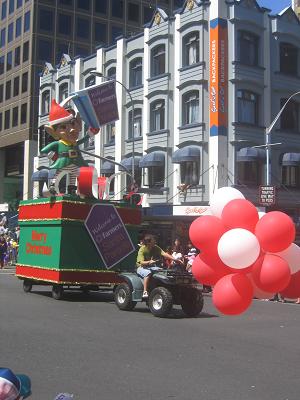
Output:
[{"xmin": 16, "ymin": 82, "xmax": 141, "ymax": 299}]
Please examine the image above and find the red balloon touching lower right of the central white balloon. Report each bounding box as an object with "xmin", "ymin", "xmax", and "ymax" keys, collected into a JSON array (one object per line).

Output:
[{"xmin": 252, "ymin": 254, "xmax": 291, "ymax": 293}]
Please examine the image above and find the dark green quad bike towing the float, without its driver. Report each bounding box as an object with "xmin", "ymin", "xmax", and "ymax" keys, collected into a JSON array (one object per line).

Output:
[{"xmin": 115, "ymin": 269, "xmax": 204, "ymax": 318}]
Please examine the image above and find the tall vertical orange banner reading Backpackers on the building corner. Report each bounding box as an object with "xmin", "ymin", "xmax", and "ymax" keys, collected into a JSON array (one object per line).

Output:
[{"xmin": 209, "ymin": 18, "xmax": 228, "ymax": 136}]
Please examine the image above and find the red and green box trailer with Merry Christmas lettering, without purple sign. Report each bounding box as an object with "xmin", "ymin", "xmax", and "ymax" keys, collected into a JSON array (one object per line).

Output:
[{"xmin": 16, "ymin": 195, "xmax": 141, "ymax": 299}]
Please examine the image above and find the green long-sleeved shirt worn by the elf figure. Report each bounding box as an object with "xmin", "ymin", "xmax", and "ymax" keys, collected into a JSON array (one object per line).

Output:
[{"xmin": 41, "ymin": 135, "xmax": 89, "ymax": 169}]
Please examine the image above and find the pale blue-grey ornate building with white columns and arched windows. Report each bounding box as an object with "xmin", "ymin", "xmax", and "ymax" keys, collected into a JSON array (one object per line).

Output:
[{"xmin": 35, "ymin": 0, "xmax": 300, "ymax": 247}]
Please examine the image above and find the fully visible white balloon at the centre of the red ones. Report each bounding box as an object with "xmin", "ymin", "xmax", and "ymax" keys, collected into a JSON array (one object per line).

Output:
[{"xmin": 218, "ymin": 228, "xmax": 260, "ymax": 269}]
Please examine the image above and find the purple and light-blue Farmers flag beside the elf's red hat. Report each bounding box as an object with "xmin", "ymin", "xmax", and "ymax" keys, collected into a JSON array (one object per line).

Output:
[{"xmin": 72, "ymin": 81, "xmax": 119, "ymax": 128}]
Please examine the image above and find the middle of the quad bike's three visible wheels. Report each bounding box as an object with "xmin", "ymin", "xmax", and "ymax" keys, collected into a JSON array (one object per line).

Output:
[{"xmin": 148, "ymin": 287, "xmax": 173, "ymax": 318}]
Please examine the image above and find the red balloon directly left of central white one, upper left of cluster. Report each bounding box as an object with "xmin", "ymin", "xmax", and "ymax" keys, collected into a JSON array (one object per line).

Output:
[{"xmin": 189, "ymin": 215, "xmax": 226, "ymax": 252}]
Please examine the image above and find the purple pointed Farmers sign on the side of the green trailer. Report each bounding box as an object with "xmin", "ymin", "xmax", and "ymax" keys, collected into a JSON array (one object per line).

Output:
[{"xmin": 84, "ymin": 204, "xmax": 136, "ymax": 269}]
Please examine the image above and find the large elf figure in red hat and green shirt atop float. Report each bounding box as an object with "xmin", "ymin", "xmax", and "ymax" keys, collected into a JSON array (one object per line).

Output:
[{"xmin": 41, "ymin": 100, "xmax": 99, "ymax": 195}]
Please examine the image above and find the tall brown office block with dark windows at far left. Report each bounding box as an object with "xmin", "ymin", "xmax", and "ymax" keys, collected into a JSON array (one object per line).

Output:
[{"xmin": 0, "ymin": 0, "xmax": 182, "ymax": 206}]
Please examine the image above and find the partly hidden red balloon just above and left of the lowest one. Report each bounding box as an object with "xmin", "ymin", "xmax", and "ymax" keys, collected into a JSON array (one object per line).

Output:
[{"xmin": 192, "ymin": 254, "xmax": 231, "ymax": 286}]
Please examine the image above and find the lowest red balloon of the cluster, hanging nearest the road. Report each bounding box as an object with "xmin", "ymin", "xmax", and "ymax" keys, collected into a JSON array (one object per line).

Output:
[{"xmin": 212, "ymin": 273, "xmax": 253, "ymax": 315}]
